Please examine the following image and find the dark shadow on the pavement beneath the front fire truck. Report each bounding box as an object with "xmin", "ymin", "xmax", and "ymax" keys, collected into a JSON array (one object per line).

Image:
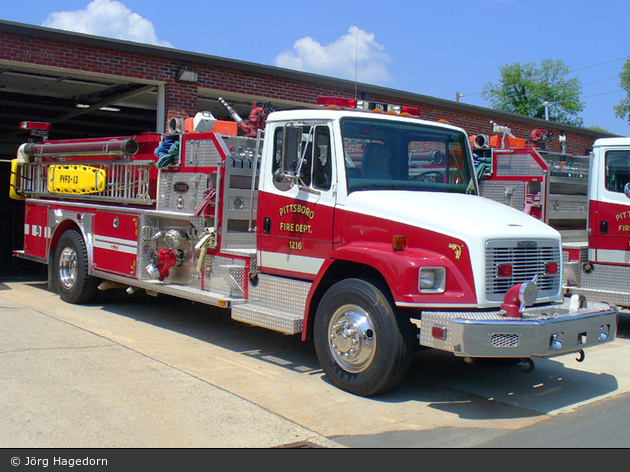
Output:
[{"xmin": 19, "ymin": 282, "xmax": 630, "ymax": 420}]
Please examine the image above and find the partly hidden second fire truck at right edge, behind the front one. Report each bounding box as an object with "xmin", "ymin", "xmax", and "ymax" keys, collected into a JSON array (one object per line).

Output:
[{"xmin": 472, "ymin": 131, "xmax": 630, "ymax": 308}]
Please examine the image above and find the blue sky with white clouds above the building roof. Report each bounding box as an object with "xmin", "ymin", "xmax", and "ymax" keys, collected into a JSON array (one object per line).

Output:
[{"xmin": 0, "ymin": 0, "xmax": 630, "ymax": 138}]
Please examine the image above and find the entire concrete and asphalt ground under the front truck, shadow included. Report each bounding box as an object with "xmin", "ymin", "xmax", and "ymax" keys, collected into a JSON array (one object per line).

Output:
[{"xmin": 0, "ymin": 281, "xmax": 630, "ymax": 450}]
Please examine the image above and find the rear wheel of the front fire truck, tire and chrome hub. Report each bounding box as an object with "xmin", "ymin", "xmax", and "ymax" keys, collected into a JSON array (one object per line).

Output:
[{"xmin": 52, "ymin": 230, "xmax": 98, "ymax": 305}]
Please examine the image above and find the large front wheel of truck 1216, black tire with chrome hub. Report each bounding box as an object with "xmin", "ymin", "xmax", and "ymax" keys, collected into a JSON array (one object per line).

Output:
[{"xmin": 313, "ymin": 279, "xmax": 413, "ymax": 397}]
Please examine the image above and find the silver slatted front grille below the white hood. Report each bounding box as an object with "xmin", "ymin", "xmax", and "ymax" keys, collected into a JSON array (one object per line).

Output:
[{"xmin": 486, "ymin": 240, "xmax": 561, "ymax": 301}]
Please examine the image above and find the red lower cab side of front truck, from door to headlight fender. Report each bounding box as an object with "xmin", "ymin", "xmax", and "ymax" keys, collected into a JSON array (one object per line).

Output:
[{"xmin": 258, "ymin": 192, "xmax": 476, "ymax": 305}]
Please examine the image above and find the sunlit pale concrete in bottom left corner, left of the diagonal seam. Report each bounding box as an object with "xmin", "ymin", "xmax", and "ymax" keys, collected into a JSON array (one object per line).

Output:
[{"xmin": 0, "ymin": 284, "xmax": 338, "ymax": 448}]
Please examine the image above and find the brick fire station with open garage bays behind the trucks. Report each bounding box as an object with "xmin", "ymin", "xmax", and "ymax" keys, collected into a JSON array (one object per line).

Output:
[{"xmin": 0, "ymin": 21, "xmax": 620, "ymax": 275}]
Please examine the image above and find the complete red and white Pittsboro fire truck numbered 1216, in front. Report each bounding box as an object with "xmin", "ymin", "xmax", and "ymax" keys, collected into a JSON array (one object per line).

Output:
[{"xmin": 11, "ymin": 98, "xmax": 617, "ymax": 396}]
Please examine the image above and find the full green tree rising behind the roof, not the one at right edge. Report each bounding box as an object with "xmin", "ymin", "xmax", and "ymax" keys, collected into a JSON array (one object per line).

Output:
[{"xmin": 480, "ymin": 59, "xmax": 584, "ymax": 126}]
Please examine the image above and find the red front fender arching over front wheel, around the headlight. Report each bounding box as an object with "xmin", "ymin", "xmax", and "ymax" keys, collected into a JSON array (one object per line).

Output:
[{"xmin": 302, "ymin": 242, "xmax": 477, "ymax": 336}]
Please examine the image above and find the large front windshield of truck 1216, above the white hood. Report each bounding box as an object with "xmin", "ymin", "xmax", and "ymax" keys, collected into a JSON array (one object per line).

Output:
[{"xmin": 341, "ymin": 118, "xmax": 477, "ymax": 194}]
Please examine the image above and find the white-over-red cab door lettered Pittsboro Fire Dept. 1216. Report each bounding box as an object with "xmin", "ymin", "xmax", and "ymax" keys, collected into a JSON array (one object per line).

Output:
[{"xmin": 257, "ymin": 121, "xmax": 336, "ymax": 280}]
